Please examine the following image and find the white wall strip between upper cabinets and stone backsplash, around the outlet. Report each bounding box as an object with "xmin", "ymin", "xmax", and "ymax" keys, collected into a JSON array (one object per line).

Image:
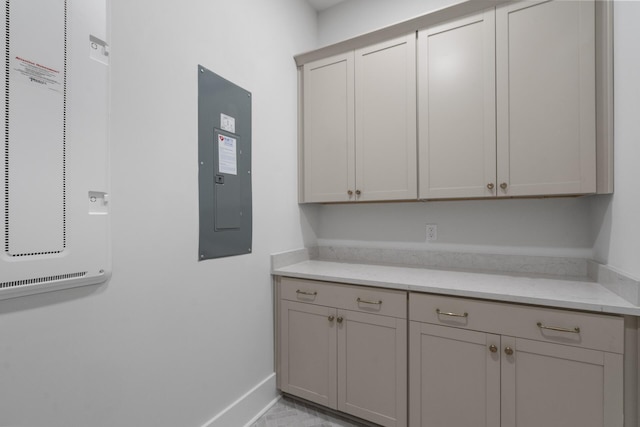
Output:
[{"xmin": 317, "ymin": 198, "xmax": 592, "ymax": 257}]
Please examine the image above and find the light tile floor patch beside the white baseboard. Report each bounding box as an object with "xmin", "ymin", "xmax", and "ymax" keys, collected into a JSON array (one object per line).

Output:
[{"xmin": 251, "ymin": 396, "xmax": 366, "ymax": 427}]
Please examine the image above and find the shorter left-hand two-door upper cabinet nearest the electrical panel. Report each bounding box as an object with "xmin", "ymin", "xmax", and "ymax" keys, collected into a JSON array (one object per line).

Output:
[{"xmin": 301, "ymin": 34, "xmax": 417, "ymax": 203}]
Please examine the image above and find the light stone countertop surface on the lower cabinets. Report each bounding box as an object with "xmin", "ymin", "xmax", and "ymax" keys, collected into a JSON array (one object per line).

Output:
[{"xmin": 272, "ymin": 260, "xmax": 640, "ymax": 316}]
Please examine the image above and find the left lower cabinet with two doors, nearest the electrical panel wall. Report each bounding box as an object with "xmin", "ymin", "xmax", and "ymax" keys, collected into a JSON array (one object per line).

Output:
[{"xmin": 278, "ymin": 278, "xmax": 407, "ymax": 427}]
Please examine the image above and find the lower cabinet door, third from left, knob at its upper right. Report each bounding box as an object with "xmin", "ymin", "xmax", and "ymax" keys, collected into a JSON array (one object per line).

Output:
[{"xmin": 409, "ymin": 322, "xmax": 502, "ymax": 427}]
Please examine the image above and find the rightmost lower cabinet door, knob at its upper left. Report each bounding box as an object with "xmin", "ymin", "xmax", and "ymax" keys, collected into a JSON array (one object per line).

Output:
[{"xmin": 502, "ymin": 337, "xmax": 624, "ymax": 427}]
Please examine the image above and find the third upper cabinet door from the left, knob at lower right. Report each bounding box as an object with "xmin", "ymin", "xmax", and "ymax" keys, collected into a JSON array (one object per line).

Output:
[{"xmin": 418, "ymin": 9, "xmax": 496, "ymax": 199}]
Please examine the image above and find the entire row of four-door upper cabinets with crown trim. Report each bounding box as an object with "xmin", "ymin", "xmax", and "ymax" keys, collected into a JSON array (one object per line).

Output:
[{"xmin": 296, "ymin": 0, "xmax": 613, "ymax": 203}]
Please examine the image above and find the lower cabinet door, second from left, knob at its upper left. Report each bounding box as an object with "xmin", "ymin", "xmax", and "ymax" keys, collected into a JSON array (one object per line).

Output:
[{"xmin": 337, "ymin": 310, "xmax": 407, "ymax": 427}]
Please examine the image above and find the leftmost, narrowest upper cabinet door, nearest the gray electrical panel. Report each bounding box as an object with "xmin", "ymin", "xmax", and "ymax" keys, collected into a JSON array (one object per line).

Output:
[{"xmin": 303, "ymin": 52, "xmax": 355, "ymax": 202}]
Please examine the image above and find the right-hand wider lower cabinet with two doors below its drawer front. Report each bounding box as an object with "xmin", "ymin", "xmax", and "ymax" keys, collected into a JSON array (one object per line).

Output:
[{"xmin": 409, "ymin": 294, "xmax": 624, "ymax": 427}]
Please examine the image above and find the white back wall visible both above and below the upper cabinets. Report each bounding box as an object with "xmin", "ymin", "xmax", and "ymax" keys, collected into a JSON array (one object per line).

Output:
[{"xmin": 317, "ymin": 0, "xmax": 594, "ymax": 257}]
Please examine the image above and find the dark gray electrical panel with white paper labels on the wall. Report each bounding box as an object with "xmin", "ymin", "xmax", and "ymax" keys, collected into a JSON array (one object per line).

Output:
[{"xmin": 198, "ymin": 65, "xmax": 252, "ymax": 260}]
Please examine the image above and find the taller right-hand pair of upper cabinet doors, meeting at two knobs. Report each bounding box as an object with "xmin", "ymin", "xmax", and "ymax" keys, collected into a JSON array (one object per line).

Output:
[{"xmin": 418, "ymin": 1, "xmax": 596, "ymax": 199}]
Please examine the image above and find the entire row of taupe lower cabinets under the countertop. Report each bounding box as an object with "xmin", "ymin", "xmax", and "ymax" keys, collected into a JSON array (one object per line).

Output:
[{"xmin": 276, "ymin": 277, "xmax": 634, "ymax": 427}]
